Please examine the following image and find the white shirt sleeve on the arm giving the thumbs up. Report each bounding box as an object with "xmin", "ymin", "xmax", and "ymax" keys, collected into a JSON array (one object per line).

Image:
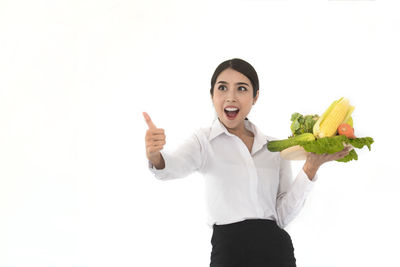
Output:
[{"xmin": 148, "ymin": 133, "xmax": 205, "ymax": 180}]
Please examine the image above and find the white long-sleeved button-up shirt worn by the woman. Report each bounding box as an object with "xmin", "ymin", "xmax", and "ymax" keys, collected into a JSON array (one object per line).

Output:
[{"xmin": 148, "ymin": 118, "xmax": 318, "ymax": 228}]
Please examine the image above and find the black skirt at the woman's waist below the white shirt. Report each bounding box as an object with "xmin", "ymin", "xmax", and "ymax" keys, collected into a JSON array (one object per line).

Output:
[{"xmin": 210, "ymin": 219, "xmax": 296, "ymax": 267}]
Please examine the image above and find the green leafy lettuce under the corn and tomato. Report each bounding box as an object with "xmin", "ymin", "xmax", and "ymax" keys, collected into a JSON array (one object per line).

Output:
[{"xmin": 299, "ymin": 135, "xmax": 374, "ymax": 162}]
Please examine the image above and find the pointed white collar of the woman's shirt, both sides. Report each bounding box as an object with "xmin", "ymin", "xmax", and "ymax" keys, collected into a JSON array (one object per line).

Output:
[{"xmin": 208, "ymin": 117, "xmax": 268, "ymax": 154}]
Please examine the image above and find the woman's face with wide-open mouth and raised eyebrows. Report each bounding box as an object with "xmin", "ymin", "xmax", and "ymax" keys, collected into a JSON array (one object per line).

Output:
[{"xmin": 212, "ymin": 69, "xmax": 258, "ymax": 134}]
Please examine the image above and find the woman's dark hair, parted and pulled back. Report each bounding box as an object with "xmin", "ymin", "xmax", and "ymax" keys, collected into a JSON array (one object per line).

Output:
[{"xmin": 210, "ymin": 58, "xmax": 259, "ymax": 98}]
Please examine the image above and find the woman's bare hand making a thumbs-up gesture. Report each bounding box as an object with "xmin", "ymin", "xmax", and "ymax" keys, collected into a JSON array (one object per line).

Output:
[{"xmin": 143, "ymin": 112, "xmax": 166, "ymax": 169}]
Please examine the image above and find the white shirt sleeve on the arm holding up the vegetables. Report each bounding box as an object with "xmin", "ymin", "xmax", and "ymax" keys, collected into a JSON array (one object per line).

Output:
[{"xmin": 276, "ymin": 158, "xmax": 318, "ymax": 228}]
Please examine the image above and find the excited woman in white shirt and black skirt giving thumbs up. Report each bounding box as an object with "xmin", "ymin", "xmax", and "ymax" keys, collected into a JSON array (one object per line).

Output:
[{"xmin": 143, "ymin": 58, "xmax": 350, "ymax": 267}]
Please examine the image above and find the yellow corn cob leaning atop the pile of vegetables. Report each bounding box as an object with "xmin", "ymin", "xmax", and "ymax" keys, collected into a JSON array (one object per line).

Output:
[{"xmin": 319, "ymin": 98, "xmax": 350, "ymax": 138}]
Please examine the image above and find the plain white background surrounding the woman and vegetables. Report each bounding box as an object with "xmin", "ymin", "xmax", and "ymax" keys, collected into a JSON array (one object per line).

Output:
[{"xmin": 0, "ymin": 0, "xmax": 400, "ymax": 267}]
